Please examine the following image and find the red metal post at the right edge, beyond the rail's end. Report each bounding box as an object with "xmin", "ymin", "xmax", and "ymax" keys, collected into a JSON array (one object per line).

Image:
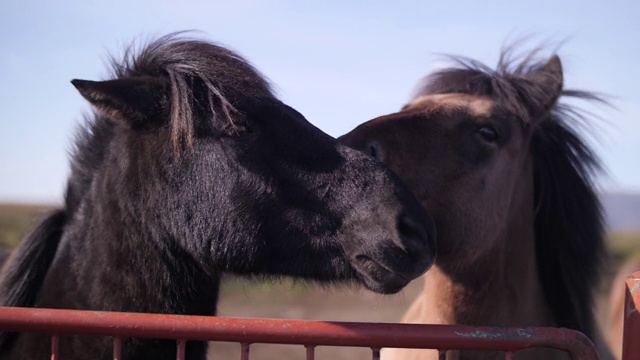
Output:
[{"xmin": 622, "ymin": 271, "xmax": 640, "ymax": 360}]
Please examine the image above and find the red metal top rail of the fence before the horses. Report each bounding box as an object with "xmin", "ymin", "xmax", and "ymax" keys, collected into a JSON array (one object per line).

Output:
[{"xmin": 0, "ymin": 307, "xmax": 598, "ymax": 359}]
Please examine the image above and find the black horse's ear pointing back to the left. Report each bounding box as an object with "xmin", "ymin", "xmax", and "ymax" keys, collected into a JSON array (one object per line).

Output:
[{"xmin": 71, "ymin": 77, "xmax": 169, "ymax": 126}]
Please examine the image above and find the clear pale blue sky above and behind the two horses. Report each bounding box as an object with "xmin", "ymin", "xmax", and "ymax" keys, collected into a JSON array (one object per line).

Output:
[{"xmin": 0, "ymin": 0, "xmax": 640, "ymax": 202}]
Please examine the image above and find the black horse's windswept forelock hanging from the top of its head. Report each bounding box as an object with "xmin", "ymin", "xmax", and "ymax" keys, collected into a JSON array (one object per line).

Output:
[{"xmin": 105, "ymin": 32, "xmax": 275, "ymax": 153}]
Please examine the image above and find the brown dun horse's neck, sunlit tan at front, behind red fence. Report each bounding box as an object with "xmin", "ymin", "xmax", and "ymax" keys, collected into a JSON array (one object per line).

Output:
[{"xmin": 398, "ymin": 169, "xmax": 566, "ymax": 360}]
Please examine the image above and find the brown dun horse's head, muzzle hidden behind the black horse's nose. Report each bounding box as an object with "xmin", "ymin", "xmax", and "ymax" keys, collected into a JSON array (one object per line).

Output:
[{"xmin": 340, "ymin": 56, "xmax": 562, "ymax": 265}]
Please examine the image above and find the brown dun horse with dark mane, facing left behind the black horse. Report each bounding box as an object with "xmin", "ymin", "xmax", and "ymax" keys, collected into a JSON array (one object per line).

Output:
[{"xmin": 339, "ymin": 49, "xmax": 608, "ymax": 359}]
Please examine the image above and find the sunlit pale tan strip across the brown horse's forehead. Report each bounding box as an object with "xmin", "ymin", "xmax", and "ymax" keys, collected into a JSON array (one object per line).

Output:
[{"xmin": 404, "ymin": 94, "xmax": 493, "ymax": 117}]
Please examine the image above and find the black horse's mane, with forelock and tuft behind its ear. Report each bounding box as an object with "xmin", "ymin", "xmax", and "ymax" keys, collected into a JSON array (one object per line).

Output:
[{"xmin": 65, "ymin": 32, "xmax": 274, "ymax": 214}]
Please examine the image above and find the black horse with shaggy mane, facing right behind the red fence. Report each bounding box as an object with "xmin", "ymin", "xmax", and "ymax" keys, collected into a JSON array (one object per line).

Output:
[{"xmin": 0, "ymin": 34, "xmax": 435, "ymax": 359}]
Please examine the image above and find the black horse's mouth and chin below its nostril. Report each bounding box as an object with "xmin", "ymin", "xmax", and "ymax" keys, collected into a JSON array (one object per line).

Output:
[{"xmin": 352, "ymin": 255, "xmax": 412, "ymax": 294}]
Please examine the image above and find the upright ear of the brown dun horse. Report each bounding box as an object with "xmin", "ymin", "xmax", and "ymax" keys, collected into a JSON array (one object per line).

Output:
[{"xmin": 526, "ymin": 55, "xmax": 564, "ymax": 115}]
